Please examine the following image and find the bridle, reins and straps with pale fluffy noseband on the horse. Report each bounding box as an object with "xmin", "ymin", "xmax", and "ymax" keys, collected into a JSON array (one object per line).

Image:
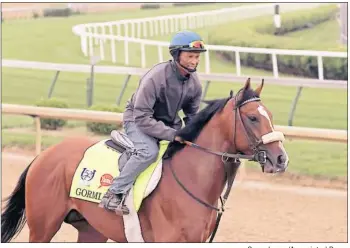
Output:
[{"xmin": 169, "ymin": 89, "xmax": 284, "ymax": 242}]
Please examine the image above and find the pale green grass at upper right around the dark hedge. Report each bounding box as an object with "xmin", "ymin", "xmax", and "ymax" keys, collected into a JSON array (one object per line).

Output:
[{"xmin": 207, "ymin": 4, "xmax": 347, "ymax": 52}]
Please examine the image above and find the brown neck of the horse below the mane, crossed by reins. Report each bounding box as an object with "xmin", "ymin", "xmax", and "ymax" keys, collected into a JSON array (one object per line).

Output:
[{"xmin": 174, "ymin": 116, "xmax": 229, "ymax": 204}]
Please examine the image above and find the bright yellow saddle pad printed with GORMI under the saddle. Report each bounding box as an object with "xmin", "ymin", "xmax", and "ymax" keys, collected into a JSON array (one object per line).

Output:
[{"xmin": 69, "ymin": 140, "xmax": 169, "ymax": 211}]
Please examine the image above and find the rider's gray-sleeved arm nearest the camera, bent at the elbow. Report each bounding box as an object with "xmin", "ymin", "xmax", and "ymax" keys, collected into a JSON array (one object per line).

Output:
[{"xmin": 134, "ymin": 78, "xmax": 176, "ymax": 141}]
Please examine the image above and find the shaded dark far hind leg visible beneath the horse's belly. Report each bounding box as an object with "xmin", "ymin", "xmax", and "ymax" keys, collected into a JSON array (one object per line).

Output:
[{"xmin": 71, "ymin": 220, "xmax": 108, "ymax": 243}]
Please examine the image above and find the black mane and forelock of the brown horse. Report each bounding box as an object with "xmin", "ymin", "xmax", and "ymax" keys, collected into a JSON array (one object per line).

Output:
[{"xmin": 163, "ymin": 88, "xmax": 258, "ymax": 159}]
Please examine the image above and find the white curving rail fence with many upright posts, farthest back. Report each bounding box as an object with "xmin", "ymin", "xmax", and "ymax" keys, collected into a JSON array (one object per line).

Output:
[{"xmin": 73, "ymin": 3, "xmax": 347, "ymax": 80}]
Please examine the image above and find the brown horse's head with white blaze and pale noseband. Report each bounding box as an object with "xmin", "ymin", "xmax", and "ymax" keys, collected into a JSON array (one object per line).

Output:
[{"xmin": 221, "ymin": 79, "xmax": 289, "ymax": 173}]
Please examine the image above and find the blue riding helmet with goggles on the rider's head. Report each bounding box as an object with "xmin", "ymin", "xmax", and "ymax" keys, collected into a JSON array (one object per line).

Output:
[{"xmin": 169, "ymin": 31, "xmax": 207, "ymax": 60}]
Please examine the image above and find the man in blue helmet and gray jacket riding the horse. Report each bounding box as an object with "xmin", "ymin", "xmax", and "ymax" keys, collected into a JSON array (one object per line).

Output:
[{"xmin": 99, "ymin": 31, "xmax": 206, "ymax": 215}]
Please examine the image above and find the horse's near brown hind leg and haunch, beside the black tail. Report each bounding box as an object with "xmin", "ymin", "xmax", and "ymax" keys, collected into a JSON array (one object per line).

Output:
[{"xmin": 25, "ymin": 148, "xmax": 70, "ymax": 242}]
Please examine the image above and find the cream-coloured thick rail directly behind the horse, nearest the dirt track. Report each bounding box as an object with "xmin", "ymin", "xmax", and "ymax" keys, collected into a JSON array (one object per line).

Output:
[{"xmin": 1, "ymin": 103, "xmax": 347, "ymax": 154}]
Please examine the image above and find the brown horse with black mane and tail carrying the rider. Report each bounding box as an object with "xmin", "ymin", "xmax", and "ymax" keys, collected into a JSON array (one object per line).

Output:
[{"xmin": 1, "ymin": 79, "xmax": 289, "ymax": 242}]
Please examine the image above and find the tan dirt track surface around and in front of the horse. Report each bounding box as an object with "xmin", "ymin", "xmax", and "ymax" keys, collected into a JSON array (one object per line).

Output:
[{"xmin": 2, "ymin": 153, "xmax": 347, "ymax": 242}]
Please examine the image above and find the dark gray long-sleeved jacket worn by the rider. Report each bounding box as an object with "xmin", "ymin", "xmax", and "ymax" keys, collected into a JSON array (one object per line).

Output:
[{"xmin": 123, "ymin": 60, "xmax": 202, "ymax": 141}]
